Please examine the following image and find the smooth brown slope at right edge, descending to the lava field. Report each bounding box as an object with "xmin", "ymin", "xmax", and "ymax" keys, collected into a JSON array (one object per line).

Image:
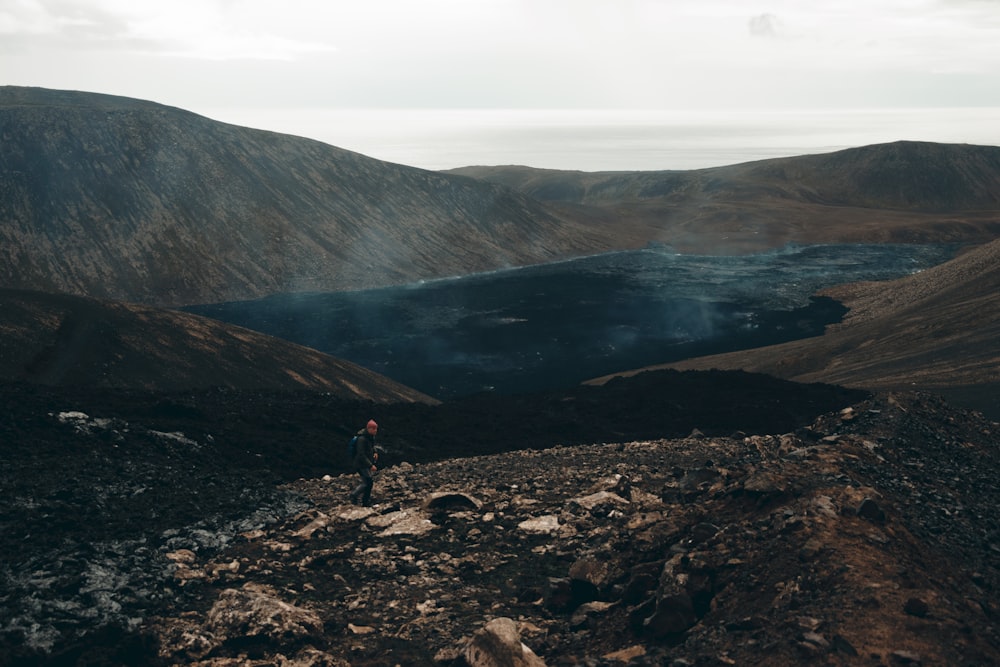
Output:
[{"xmin": 584, "ymin": 240, "xmax": 1000, "ymax": 414}]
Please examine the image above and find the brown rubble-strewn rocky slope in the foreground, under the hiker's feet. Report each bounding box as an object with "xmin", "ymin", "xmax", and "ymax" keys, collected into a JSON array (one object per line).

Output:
[{"xmin": 145, "ymin": 395, "xmax": 1000, "ymax": 667}]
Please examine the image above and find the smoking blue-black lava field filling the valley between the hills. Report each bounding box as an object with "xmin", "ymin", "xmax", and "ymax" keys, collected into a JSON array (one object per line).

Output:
[{"xmin": 186, "ymin": 244, "xmax": 955, "ymax": 399}]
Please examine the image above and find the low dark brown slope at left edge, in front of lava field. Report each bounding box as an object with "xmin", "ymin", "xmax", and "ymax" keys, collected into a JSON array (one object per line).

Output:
[{"xmin": 0, "ymin": 290, "xmax": 437, "ymax": 403}]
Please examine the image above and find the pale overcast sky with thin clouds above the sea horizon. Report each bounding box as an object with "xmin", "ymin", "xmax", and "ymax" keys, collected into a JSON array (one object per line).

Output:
[{"xmin": 0, "ymin": 0, "xmax": 1000, "ymax": 164}]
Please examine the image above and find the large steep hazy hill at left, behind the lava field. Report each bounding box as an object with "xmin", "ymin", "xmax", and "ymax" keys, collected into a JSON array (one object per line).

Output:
[{"xmin": 0, "ymin": 87, "xmax": 613, "ymax": 305}]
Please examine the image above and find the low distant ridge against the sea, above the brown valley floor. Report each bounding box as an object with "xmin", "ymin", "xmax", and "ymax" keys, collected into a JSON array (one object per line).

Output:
[{"xmin": 447, "ymin": 141, "xmax": 1000, "ymax": 213}]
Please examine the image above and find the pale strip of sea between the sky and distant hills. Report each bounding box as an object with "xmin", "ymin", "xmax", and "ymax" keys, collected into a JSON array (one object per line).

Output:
[{"xmin": 199, "ymin": 107, "xmax": 1000, "ymax": 171}]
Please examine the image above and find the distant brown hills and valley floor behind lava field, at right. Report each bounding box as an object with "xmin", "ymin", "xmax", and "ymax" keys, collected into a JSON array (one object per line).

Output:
[{"xmin": 448, "ymin": 141, "xmax": 1000, "ymax": 254}]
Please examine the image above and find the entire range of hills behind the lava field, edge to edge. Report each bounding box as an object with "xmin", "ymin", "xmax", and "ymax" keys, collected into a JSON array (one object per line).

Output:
[{"xmin": 0, "ymin": 87, "xmax": 1000, "ymax": 306}]
